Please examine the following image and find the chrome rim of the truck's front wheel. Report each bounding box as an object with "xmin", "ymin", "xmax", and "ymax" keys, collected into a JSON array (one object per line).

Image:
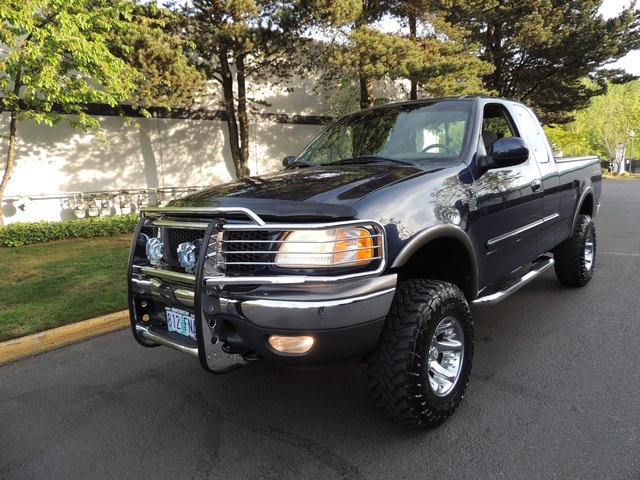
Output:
[{"xmin": 427, "ymin": 317, "xmax": 464, "ymax": 397}]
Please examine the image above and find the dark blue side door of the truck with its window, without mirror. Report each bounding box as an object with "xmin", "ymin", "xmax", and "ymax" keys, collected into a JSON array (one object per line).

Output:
[{"xmin": 475, "ymin": 103, "xmax": 544, "ymax": 285}]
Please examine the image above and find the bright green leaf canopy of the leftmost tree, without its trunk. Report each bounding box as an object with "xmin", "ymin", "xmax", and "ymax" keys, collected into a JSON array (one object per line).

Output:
[{"xmin": 0, "ymin": 0, "xmax": 140, "ymax": 130}]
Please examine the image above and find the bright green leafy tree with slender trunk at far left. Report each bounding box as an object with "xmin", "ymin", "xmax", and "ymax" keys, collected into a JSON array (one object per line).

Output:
[{"xmin": 0, "ymin": 0, "xmax": 202, "ymax": 225}]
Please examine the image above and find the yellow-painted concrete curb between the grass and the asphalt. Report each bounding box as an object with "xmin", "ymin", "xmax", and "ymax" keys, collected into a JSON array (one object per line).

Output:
[{"xmin": 0, "ymin": 310, "xmax": 130, "ymax": 365}]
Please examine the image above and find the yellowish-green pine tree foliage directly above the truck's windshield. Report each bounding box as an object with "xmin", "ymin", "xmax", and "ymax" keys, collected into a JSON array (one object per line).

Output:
[{"xmin": 324, "ymin": 0, "xmax": 492, "ymax": 108}]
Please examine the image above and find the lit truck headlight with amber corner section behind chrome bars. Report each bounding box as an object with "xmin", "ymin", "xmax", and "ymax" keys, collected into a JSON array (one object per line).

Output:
[{"xmin": 275, "ymin": 227, "xmax": 376, "ymax": 268}]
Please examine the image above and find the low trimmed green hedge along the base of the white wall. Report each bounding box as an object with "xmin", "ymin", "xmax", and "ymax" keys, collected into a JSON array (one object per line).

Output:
[{"xmin": 0, "ymin": 214, "xmax": 140, "ymax": 247}]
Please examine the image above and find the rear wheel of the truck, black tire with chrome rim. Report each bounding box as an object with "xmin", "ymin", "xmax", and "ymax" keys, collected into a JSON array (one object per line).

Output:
[{"xmin": 554, "ymin": 215, "xmax": 596, "ymax": 287}]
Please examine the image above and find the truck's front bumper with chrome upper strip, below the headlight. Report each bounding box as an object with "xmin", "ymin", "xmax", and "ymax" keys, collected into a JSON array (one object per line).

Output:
[{"xmin": 130, "ymin": 275, "xmax": 396, "ymax": 372}]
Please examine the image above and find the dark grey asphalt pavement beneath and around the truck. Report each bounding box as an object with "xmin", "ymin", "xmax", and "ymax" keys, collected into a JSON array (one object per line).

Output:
[{"xmin": 0, "ymin": 180, "xmax": 640, "ymax": 480}]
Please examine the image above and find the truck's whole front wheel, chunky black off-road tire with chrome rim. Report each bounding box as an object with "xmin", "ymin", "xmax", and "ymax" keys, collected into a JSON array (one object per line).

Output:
[{"xmin": 367, "ymin": 280, "xmax": 474, "ymax": 429}]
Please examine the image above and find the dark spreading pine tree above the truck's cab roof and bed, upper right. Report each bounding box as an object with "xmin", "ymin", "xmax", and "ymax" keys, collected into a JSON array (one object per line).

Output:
[{"xmin": 432, "ymin": 0, "xmax": 640, "ymax": 123}]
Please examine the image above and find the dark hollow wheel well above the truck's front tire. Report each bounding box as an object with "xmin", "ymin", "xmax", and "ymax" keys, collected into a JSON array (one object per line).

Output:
[{"xmin": 396, "ymin": 237, "xmax": 475, "ymax": 299}]
